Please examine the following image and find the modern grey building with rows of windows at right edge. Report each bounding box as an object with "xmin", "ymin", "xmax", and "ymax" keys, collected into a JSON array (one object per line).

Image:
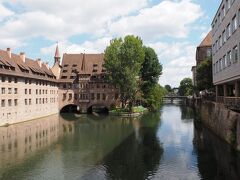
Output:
[{"xmin": 212, "ymin": 0, "xmax": 240, "ymax": 110}]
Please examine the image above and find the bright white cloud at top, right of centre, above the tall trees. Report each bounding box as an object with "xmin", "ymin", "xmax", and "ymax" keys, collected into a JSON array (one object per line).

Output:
[{"xmin": 109, "ymin": 0, "xmax": 202, "ymax": 40}]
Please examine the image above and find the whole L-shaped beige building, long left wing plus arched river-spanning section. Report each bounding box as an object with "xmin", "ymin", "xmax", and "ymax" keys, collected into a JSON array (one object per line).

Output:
[{"xmin": 0, "ymin": 46, "xmax": 119, "ymax": 126}]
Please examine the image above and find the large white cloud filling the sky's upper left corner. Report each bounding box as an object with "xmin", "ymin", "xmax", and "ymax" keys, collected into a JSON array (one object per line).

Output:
[{"xmin": 0, "ymin": 0, "xmax": 147, "ymax": 41}]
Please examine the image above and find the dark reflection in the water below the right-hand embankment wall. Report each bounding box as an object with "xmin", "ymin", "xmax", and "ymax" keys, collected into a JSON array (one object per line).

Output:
[{"xmin": 193, "ymin": 122, "xmax": 240, "ymax": 180}]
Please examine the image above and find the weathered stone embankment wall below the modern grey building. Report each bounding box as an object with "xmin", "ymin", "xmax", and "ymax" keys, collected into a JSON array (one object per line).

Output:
[{"xmin": 195, "ymin": 101, "xmax": 240, "ymax": 151}]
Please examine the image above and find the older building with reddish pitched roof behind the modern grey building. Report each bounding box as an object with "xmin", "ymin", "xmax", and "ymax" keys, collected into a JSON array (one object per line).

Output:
[{"xmin": 192, "ymin": 31, "xmax": 212, "ymax": 86}]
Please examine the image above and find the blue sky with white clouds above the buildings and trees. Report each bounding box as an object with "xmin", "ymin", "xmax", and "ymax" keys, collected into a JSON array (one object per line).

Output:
[{"xmin": 0, "ymin": 0, "xmax": 221, "ymax": 87}]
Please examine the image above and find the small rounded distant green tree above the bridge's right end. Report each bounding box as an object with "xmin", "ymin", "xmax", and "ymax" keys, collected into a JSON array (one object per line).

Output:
[{"xmin": 179, "ymin": 78, "xmax": 193, "ymax": 96}]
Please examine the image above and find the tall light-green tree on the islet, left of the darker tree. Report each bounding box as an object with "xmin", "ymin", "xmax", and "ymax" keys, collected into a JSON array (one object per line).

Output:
[{"xmin": 104, "ymin": 35, "xmax": 144, "ymax": 108}]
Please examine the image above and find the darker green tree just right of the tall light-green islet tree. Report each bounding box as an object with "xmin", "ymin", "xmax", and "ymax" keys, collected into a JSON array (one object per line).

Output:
[{"xmin": 140, "ymin": 46, "xmax": 162, "ymax": 98}]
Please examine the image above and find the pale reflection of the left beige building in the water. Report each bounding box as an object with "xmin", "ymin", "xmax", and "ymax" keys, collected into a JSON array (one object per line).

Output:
[{"xmin": 0, "ymin": 115, "xmax": 76, "ymax": 170}]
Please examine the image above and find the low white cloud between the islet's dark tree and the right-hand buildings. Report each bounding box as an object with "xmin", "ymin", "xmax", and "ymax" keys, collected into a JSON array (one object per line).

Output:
[{"xmin": 148, "ymin": 42, "xmax": 196, "ymax": 87}]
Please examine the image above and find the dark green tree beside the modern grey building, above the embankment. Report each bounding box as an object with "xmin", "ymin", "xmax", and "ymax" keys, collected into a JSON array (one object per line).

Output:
[{"xmin": 196, "ymin": 58, "xmax": 213, "ymax": 91}]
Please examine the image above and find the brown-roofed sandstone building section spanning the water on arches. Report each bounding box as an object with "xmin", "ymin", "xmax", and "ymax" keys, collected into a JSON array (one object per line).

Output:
[{"xmin": 57, "ymin": 53, "xmax": 118, "ymax": 113}]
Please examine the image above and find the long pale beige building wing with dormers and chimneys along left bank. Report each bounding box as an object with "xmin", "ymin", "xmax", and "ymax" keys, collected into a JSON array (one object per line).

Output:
[{"xmin": 0, "ymin": 48, "xmax": 58, "ymax": 126}]
